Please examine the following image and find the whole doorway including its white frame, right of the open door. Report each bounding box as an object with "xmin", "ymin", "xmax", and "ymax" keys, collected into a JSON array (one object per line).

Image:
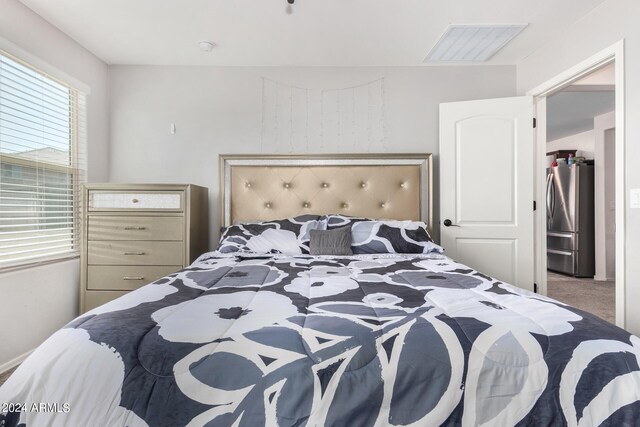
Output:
[{"xmin": 529, "ymin": 41, "xmax": 625, "ymax": 327}]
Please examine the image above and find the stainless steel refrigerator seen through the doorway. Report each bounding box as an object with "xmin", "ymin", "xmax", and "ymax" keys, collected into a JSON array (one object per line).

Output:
[{"xmin": 547, "ymin": 163, "xmax": 595, "ymax": 277}]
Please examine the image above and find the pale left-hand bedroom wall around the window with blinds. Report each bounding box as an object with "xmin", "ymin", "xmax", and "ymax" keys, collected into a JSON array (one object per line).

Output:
[{"xmin": 0, "ymin": 0, "xmax": 109, "ymax": 372}]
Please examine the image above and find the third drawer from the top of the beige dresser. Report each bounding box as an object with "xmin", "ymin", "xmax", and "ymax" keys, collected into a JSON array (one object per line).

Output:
[{"xmin": 87, "ymin": 240, "xmax": 184, "ymax": 265}]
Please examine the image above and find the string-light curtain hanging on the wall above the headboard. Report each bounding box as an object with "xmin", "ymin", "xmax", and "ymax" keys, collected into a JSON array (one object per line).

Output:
[{"xmin": 260, "ymin": 77, "xmax": 388, "ymax": 153}]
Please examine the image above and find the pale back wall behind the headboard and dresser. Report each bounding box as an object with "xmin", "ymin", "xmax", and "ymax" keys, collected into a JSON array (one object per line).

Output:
[{"xmin": 109, "ymin": 66, "xmax": 516, "ymax": 244}]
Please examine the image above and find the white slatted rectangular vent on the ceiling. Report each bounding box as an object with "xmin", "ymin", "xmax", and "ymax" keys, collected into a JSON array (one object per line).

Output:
[{"xmin": 426, "ymin": 24, "xmax": 527, "ymax": 62}]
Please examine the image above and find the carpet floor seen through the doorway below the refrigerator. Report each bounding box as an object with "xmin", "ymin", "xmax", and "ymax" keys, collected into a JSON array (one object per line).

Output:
[{"xmin": 547, "ymin": 271, "xmax": 616, "ymax": 323}]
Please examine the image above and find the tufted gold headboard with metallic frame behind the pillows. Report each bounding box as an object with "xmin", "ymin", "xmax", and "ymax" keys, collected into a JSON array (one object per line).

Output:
[{"xmin": 219, "ymin": 153, "xmax": 433, "ymax": 228}]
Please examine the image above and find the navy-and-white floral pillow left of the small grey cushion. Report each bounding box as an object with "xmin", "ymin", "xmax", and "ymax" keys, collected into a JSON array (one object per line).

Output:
[{"xmin": 217, "ymin": 215, "xmax": 326, "ymax": 255}]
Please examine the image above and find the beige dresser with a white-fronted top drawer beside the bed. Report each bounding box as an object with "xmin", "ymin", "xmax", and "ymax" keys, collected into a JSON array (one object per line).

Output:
[{"xmin": 80, "ymin": 184, "xmax": 209, "ymax": 313}]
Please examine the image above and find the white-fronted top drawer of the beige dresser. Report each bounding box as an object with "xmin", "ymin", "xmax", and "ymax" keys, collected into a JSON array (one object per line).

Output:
[{"xmin": 88, "ymin": 190, "xmax": 184, "ymax": 212}]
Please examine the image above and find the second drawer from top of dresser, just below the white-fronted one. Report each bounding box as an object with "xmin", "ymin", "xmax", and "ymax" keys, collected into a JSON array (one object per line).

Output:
[{"xmin": 88, "ymin": 215, "xmax": 184, "ymax": 240}]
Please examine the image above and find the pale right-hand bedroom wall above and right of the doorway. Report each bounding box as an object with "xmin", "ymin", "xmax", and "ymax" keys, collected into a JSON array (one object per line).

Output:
[{"xmin": 517, "ymin": 0, "xmax": 640, "ymax": 334}]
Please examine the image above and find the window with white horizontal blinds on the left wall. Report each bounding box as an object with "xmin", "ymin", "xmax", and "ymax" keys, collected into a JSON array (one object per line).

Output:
[{"xmin": 0, "ymin": 51, "xmax": 86, "ymax": 268}]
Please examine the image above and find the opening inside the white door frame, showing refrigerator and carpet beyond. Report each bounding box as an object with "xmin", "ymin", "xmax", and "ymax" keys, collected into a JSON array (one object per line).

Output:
[{"xmin": 544, "ymin": 63, "xmax": 615, "ymax": 323}]
